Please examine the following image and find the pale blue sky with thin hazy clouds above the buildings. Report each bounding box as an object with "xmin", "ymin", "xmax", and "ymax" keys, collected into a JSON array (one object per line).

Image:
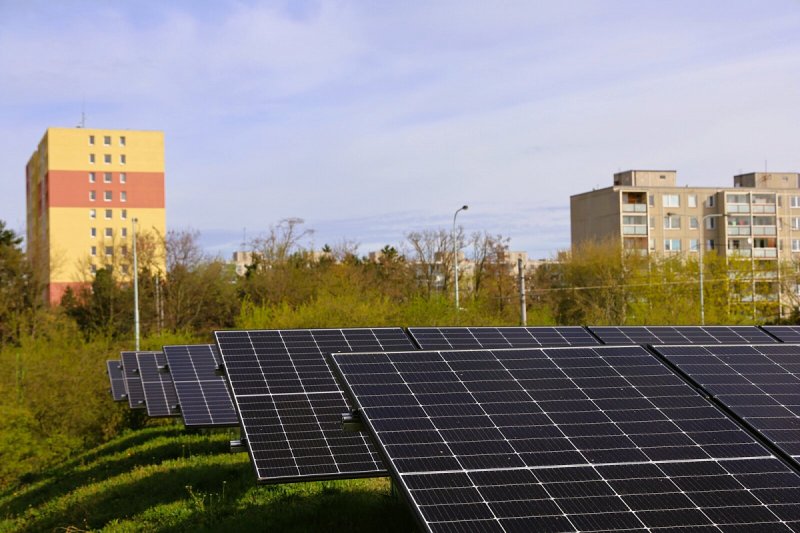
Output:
[{"xmin": 0, "ymin": 0, "xmax": 800, "ymax": 257}]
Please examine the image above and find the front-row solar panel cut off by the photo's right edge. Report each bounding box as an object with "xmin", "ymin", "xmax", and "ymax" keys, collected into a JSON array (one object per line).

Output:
[{"xmin": 654, "ymin": 344, "xmax": 800, "ymax": 463}]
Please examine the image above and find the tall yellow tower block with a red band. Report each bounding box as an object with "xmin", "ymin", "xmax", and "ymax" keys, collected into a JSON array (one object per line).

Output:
[{"xmin": 26, "ymin": 128, "xmax": 166, "ymax": 303}]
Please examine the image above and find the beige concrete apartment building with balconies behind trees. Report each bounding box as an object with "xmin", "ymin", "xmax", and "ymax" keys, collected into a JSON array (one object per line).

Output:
[{"xmin": 570, "ymin": 170, "xmax": 800, "ymax": 312}]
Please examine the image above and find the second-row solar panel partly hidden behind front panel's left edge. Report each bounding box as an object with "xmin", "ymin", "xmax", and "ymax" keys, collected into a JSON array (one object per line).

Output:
[{"xmin": 215, "ymin": 328, "xmax": 414, "ymax": 483}]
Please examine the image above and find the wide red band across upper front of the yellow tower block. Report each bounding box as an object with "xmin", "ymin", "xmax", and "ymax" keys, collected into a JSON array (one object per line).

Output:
[{"xmin": 47, "ymin": 170, "xmax": 164, "ymax": 209}]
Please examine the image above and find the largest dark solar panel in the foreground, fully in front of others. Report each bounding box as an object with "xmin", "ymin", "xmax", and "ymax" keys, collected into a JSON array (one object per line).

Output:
[{"xmin": 329, "ymin": 346, "xmax": 800, "ymax": 532}]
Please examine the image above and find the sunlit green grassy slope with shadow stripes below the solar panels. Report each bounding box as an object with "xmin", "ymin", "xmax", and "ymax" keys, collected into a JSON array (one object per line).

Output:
[{"xmin": 0, "ymin": 426, "xmax": 413, "ymax": 533}]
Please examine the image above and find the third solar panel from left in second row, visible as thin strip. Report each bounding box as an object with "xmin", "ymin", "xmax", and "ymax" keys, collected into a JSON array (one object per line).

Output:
[{"xmin": 589, "ymin": 326, "xmax": 777, "ymax": 344}]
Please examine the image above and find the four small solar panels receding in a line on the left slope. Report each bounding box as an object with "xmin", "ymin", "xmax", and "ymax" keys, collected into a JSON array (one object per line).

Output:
[{"xmin": 106, "ymin": 344, "xmax": 239, "ymax": 428}]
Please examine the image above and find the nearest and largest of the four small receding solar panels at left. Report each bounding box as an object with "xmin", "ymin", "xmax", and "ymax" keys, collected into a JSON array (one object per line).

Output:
[{"xmin": 164, "ymin": 344, "xmax": 239, "ymax": 428}]
